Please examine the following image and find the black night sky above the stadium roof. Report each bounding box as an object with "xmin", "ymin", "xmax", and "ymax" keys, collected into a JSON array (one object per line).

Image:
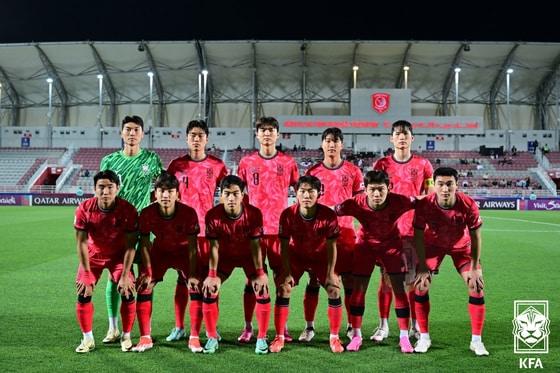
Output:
[{"xmin": 0, "ymin": 0, "xmax": 560, "ymax": 43}]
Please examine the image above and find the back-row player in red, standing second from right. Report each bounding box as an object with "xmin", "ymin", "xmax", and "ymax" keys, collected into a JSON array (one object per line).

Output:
[{"xmin": 299, "ymin": 127, "xmax": 364, "ymax": 342}]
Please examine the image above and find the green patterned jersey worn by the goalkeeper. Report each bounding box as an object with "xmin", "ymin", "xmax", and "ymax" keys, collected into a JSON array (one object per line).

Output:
[{"xmin": 99, "ymin": 149, "xmax": 163, "ymax": 212}]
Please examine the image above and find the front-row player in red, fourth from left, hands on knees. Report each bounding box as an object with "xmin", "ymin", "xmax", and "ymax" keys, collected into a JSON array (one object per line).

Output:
[{"xmin": 270, "ymin": 176, "xmax": 344, "ymax": 353}]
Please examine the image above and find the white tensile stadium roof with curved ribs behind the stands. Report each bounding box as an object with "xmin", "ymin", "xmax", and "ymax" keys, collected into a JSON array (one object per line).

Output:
[{"xmin": 0, "ymin": 40, "xmax": 560, "ymax": 129}]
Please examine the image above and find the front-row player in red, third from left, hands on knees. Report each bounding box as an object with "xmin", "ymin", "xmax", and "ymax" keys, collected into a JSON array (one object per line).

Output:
[{"xmin": 202, "ymin": 175, "xmax": 270, "ymax": 354}]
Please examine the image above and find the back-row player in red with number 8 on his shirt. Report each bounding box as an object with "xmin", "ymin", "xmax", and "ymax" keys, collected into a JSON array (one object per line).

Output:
[{"xmin": 237, "ymin": 117, "xmax": 299, "ymax": 343}]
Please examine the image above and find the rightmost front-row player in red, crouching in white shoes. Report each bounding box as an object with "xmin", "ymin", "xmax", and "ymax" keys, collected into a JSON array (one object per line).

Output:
[{"xmin": 413, "ymin": 167, "xmax": 489, "ymax": 356}]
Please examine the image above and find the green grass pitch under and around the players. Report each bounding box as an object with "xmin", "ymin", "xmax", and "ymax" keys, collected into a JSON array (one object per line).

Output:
[{"xmin": 0, "ymin": 207, "xmax": 560, "ymax": 372}]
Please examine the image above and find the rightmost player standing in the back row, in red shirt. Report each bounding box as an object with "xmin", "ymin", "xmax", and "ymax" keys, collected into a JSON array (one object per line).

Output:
[{"xmin": 370, "ymin": 120, "xmax": 434, "ymax": 342}]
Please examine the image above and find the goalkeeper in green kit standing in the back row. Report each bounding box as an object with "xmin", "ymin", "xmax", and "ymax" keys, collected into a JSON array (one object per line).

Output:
[{"xmin": 99, "ymin": 115, "xmax": 162, "ymax": 345}]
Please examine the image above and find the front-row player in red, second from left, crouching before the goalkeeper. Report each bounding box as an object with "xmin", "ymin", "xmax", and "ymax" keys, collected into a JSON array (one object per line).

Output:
[{"xmin": 132, "ymin": 171, "xmax": 202, "ymax": 352}]
